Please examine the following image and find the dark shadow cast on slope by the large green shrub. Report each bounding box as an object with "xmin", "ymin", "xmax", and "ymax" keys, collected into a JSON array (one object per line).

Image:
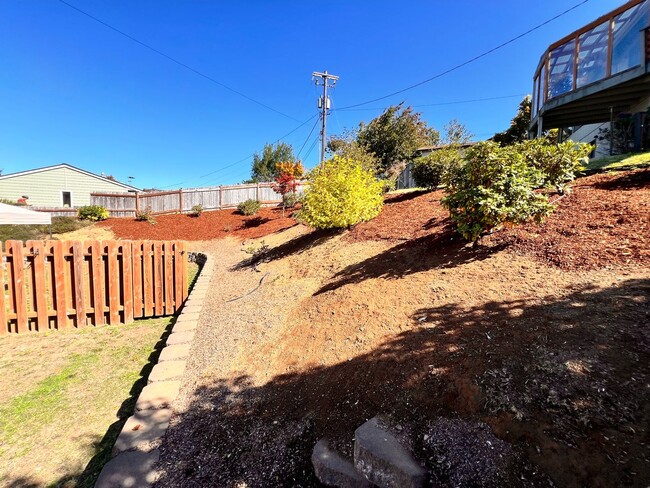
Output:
[{"xmin": 314, "ymin": 228, "xmax": 507, "ymax": 295}]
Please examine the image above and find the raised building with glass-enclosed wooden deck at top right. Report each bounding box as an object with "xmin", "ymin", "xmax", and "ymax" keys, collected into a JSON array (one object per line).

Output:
[{"xmin": 530, "ymin": 0, "xmax": 650, "ymax": 152}]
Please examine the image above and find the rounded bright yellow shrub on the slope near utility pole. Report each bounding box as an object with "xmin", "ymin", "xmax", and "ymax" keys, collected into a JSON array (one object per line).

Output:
[{"xmin": 300, "ymin": 156, "xmax": 384, "ymax": 229}]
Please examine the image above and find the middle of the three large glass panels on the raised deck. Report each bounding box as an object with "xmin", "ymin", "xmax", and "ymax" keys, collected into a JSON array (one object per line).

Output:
[{"xmin": 577, "ymin": 21, "xmax": 609, "ymax": 88}]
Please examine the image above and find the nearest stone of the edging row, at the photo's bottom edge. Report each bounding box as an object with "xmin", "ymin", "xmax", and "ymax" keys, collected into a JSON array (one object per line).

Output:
[{"xmin": 95, "ymin": 449, "xmax": 160, "ymax": 488}]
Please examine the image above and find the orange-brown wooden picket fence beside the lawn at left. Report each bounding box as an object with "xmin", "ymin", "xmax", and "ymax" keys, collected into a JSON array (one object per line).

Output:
[{"xmin": 0, "ymin": 240, "xmax": 188, "ymax": 335}]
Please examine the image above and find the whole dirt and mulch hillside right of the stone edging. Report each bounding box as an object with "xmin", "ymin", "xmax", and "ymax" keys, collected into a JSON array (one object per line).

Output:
[{"xmin": 154, "ymin": 172, "xmax": 650, "ymax": 487}]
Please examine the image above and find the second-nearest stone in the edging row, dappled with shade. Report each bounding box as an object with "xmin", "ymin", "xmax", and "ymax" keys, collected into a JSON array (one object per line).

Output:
[{"xmin": 113, "ymin": 408, "xmax": 172, "ymax": 456}]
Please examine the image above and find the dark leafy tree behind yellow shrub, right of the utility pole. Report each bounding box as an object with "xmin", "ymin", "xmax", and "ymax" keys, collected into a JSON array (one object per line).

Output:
[{"xmin": 356, "ymin": 102, "xmax": 440, "ymax": 174}]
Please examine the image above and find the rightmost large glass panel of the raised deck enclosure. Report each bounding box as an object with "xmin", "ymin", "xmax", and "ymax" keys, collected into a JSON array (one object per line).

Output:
[{"xmin": 612, "ymin": 0, "xmax": 650, "ymax": 75}]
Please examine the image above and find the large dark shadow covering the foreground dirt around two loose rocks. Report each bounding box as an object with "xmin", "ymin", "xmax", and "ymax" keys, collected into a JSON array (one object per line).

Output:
[{"xmin": 157, "ymin": 278, "xmax": 650, "ymax": 487}]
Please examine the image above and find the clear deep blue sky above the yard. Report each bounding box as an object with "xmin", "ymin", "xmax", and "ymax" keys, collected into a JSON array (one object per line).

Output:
[{"xmin": 0, "ymin": 0, "xmax": 624, "ymax": 188}]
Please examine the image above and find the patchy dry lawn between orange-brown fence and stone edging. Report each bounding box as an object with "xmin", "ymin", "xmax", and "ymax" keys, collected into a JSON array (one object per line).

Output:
[{"xmin": 0, "ymin": 318, "xmax": 171, "ymax": 487}]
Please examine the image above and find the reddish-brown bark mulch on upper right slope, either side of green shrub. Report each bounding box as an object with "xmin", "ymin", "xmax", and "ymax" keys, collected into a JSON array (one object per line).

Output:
[{"xmin": 347, "ymin": 169, "xmax": 650, "ymax": 270}]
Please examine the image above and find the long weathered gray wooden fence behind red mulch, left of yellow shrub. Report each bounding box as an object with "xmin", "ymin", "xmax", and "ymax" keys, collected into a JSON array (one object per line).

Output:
[{"xmin": 90, "ymin": 183, "xmax": 301, "ymax": 217}]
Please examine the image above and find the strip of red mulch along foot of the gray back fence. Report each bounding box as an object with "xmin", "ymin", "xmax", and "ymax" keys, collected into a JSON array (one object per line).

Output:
[{"xmin": 99, "ymin": 208, "xmax": 296, "ymax": 241}]
